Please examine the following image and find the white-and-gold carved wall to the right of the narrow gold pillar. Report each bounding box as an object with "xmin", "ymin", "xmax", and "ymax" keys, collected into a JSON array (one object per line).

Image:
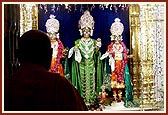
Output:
[{"xmin": 138, "ymin": 3, "xmax": 166, "ymax": 109}]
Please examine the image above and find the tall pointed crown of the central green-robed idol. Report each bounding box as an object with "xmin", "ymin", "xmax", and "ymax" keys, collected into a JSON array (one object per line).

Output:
[{"xmin": 79, "ymin": 10, "xmax": 94, "ymax": 30}]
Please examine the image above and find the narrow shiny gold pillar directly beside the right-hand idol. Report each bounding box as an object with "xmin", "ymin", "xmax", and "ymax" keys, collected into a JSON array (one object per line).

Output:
[{"xmin": 129, "ymin": 4, "xmax": 141, "ymax": 100}]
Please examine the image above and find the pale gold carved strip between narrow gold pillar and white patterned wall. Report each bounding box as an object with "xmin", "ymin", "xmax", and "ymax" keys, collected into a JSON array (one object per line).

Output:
[{"xmin": 139, "ymin": 5, "xmax": 154, "ymax": 108}]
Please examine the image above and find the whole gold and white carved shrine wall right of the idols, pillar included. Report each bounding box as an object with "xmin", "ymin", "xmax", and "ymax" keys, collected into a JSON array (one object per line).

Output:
[{"xmin": 129, "ymin": 3, "xmax": 166, "ymax": 110}]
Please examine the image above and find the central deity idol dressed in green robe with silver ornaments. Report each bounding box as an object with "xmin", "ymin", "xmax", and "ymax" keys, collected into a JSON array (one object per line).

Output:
[{"xmin": 68, "ymin": 10, "xmax": 102, "ymax": 105}]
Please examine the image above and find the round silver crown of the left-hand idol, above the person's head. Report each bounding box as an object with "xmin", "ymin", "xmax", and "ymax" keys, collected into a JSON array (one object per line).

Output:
[{"xmin": 45, "ymin": 14, "xmax": 60, "ymax": 34}]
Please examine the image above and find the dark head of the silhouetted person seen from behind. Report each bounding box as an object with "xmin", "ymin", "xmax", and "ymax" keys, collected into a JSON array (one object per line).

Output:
[{"xmin": 18, "ymin": 30, "xmax": 52, "ymax": 70}]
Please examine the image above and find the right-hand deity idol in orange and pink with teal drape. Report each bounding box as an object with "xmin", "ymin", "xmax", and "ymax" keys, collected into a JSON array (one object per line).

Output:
[{"xmin": 101, "ymin": 18, "xmax": 133, "ymax": 105}]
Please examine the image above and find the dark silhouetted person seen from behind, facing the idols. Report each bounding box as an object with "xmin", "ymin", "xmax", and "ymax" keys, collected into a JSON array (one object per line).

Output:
[{"xmin": 4, "ymin": 30, "xmax": 88, "ymax": 111}]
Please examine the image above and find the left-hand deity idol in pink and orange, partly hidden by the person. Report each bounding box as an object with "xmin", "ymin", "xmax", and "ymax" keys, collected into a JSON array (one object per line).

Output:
[{"xmin": 45, "ymin": 14, "xmax": 67, "ymax": 76}]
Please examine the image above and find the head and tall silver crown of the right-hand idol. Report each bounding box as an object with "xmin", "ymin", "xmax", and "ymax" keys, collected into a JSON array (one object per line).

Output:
[{"xmin": 110, "ymin": 18, "xmax": 124, "ymax": 41}]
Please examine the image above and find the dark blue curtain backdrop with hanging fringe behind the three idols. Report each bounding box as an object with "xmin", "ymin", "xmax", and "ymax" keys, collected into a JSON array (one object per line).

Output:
[{"xmin": 38, "ymin": 4, "xmax": 130, "ymax": 53}]
